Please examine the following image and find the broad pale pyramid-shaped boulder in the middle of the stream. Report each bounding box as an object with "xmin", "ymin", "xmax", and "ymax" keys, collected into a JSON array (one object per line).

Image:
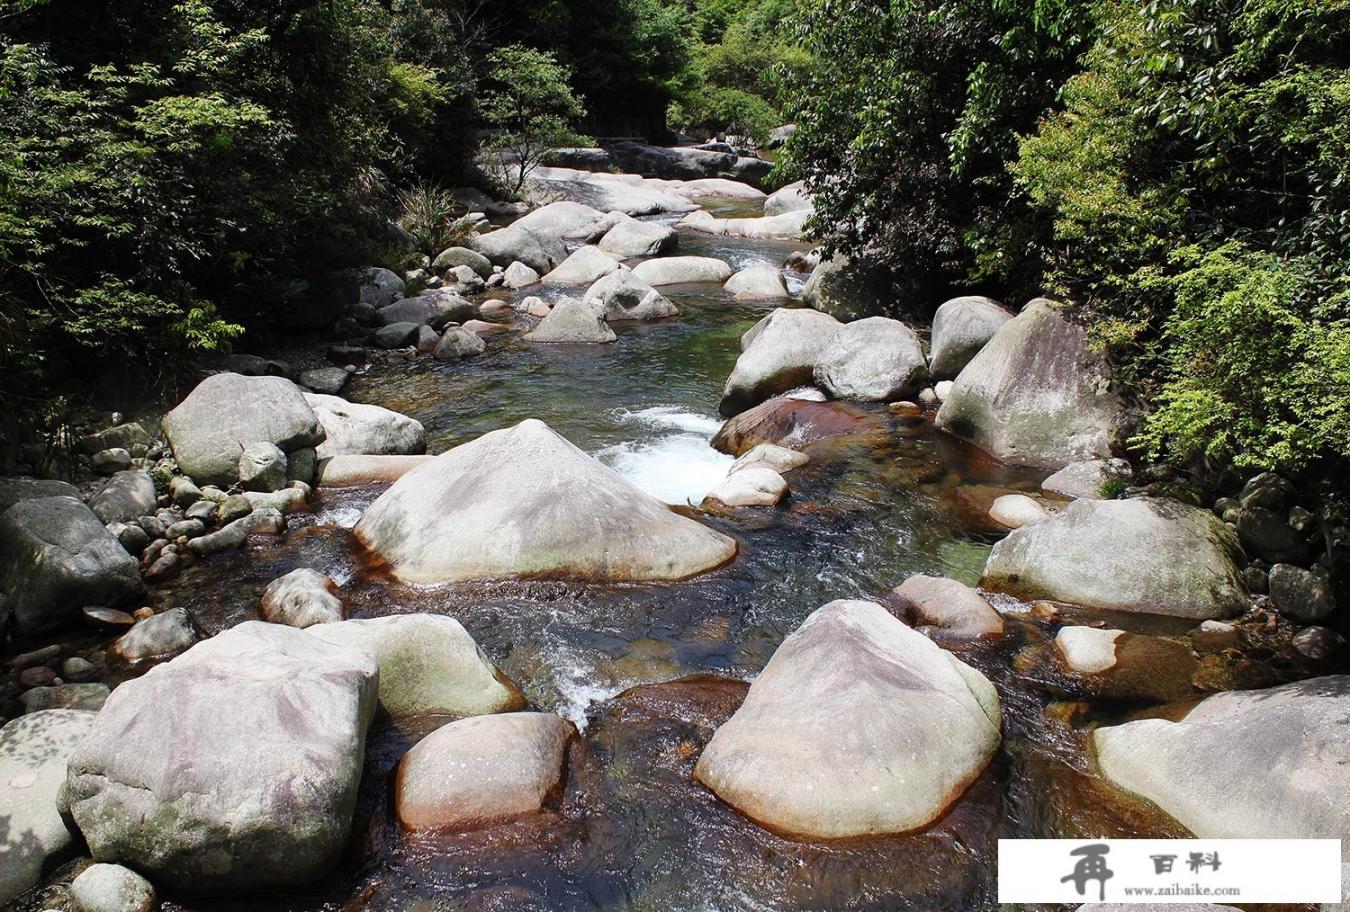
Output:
[{"xmin": 352, "ymin": 420, "xmax": 736, "ymax": 583}]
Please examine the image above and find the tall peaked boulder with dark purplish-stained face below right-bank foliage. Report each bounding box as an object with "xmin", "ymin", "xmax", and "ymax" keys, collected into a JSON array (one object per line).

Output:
[{"xmin": 937, "ymin": 298, "xmax": 1121, "ymax": 469}]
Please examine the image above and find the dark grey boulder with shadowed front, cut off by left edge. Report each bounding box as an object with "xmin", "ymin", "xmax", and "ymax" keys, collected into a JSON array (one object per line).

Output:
[{"xmin": 0, "ymin": 496, "xmax": 142, "ymax": 635}]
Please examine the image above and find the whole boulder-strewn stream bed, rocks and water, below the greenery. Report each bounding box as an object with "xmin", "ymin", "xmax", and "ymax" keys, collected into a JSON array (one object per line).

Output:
[{"xmin": 0, "ymin": 158, "xmax": 1350, "ymax": 909}]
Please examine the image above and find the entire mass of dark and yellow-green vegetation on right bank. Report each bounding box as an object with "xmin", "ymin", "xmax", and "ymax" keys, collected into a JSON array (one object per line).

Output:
[{"xmin": 788, "ymin": 0, "xmax": 1350, "ymax": 476}]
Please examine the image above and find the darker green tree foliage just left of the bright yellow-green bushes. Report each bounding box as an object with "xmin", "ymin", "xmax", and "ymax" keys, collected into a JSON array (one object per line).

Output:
[{"xmin": 782, "ymin": 0, "xmax": 1092, "ymax": 299}]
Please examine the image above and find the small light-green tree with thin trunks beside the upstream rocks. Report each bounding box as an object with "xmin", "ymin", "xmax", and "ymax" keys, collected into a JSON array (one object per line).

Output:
[{"xmin": 478, "ymin": 45, "xmax": 589, "ymax": 194}]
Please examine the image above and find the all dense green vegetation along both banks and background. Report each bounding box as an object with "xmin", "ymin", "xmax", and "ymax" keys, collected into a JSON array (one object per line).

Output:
[{"xmin": 0, "ymin": 0, "xmax": 1350, "ymax": 485}]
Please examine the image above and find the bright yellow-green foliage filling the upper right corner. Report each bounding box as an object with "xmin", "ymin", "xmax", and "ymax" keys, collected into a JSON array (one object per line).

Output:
[{"xmin": 1014, "ymin": 0, "xmax": 1350, "ymax": 471}]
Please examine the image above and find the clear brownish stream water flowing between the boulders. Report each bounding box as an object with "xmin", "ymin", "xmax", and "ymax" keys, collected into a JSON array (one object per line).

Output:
[{"xmin": 13, "ymin": 195, "xmax": 1225, "ymax": 912}]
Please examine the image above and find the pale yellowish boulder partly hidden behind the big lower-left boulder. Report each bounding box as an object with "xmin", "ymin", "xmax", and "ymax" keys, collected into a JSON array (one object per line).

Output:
[{"xmin": 308, "ymin": 614, "xmax": 525, "ymax": 716}]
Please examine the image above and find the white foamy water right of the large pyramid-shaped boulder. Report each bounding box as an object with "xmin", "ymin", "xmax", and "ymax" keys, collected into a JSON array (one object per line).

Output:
[{"xmin": 595, "ymin": 406, "xmax": 734, "ymax": 505}]
